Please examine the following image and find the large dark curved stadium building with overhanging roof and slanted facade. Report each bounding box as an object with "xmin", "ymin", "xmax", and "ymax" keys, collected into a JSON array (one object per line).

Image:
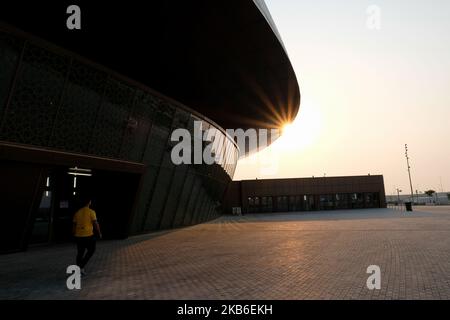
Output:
[{"xmin": 0, "ymin": 0, "xmax": 300, "ymax": 252}]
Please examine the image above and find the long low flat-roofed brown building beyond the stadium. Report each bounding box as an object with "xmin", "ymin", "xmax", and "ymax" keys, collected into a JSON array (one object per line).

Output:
[{"xmin": 225, "ymin": 175, "xmax": 386, "ymax": 214}]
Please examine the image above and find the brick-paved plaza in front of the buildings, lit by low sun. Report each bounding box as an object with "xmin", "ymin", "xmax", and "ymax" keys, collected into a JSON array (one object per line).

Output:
[{"xmin": 0, "ymin": 206, "xmax": 450, "ymax": 299}]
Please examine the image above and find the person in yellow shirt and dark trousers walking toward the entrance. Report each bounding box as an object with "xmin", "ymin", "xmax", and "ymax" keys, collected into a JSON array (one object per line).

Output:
[{"xmin": 73, "ymin": 199, "xmax": 102, "ymax": 275}]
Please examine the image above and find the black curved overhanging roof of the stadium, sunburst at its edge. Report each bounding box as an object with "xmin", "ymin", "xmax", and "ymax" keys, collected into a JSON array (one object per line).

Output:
[{"xmin": 0, "ymin": 0, "xmax": 300, "ymax": 128}]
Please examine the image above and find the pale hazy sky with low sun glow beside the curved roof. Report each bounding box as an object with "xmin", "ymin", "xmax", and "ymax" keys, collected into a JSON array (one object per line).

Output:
[{"xmin": 234, "ymin": 0, "xmax": 450, "ymax": 194}]
